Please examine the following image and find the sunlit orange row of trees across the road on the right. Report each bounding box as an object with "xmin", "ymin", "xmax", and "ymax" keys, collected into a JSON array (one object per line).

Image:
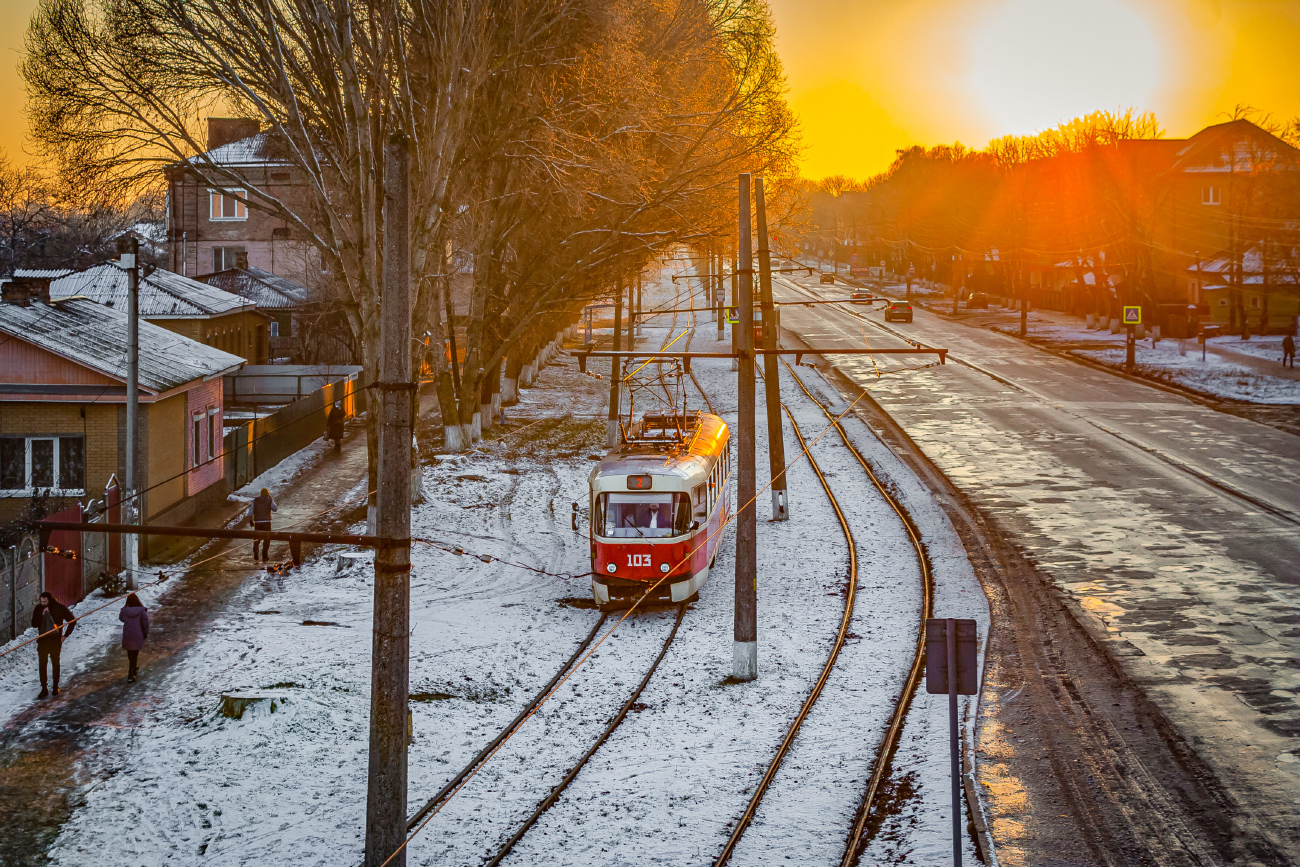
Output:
[{"xmin": 790, "ymin": 107, "xmax": 1300, "ymax": 325}]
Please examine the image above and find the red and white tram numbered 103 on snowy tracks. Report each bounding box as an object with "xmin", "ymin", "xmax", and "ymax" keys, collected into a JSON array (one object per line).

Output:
[{"xmin": 590, "ymin": 412, "xmax": 731, "ymax": 607}]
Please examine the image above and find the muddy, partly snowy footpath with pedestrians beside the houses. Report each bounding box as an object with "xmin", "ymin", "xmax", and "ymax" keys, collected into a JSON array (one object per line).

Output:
[{"xmin": 0, "ymin": 395, "xmax": 437, "ymax": 864}]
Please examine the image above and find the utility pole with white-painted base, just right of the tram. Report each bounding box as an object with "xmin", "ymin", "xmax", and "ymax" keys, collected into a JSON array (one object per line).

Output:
[{"xmin": 732, "ymin": 173, "xmax": 758, "ymax": 681}]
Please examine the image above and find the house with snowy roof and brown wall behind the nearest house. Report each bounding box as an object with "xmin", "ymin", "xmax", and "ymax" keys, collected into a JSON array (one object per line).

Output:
[{"xmin": 47, "ymin": 260, "xmax": 272, "ymax": 364}]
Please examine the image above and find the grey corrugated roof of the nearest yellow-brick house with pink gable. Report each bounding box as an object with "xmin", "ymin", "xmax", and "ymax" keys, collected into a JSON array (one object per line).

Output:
[{"xmin": 0, "ymin": 298, "xmax": 244, "ymax": 394}]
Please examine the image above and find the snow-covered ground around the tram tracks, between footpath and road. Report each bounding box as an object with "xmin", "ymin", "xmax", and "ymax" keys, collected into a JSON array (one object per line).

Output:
[{"xmin": 0, "ymin": 261, "xmax": 988, "ymax": 866}]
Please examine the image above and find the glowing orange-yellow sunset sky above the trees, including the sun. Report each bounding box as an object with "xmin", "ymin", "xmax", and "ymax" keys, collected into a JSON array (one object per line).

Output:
[{"xmin": 0, "ymin": 0, "xmax": 1300, "ymax": 178}]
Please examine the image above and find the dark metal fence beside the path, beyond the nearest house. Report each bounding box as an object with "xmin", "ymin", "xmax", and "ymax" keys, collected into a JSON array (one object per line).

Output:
[{"xmin": 224, "ymin": 373, "xmax": 365, "ymax": 490}]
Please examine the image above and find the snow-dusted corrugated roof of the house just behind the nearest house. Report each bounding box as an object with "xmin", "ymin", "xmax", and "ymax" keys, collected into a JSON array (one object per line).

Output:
[{"xmin": 49, "ymin": 261, "xmax": 254, "ymax": 318}]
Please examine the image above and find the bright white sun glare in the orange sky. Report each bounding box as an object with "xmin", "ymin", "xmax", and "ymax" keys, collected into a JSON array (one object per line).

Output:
[{"xmin": 971, "ymin": 0, "xmax": 1162, "ymax": 135}]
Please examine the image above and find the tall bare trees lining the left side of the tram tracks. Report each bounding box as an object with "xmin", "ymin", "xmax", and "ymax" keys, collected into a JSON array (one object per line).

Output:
[{"xmin": 22, "ymin": 0, "xmax": 797, "ymax": 467}]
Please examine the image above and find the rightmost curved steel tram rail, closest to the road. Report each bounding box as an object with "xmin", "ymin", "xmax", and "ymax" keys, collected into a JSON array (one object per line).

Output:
[{"xmin": 785, "ymin": 364, "xmax": 935, "ymax": 867}]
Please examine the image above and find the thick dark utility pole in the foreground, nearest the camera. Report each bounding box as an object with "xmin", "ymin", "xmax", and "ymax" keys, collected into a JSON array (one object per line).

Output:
[{"xmin": 365, "ymin": 135, "xmax": 415, "ymax": 867}]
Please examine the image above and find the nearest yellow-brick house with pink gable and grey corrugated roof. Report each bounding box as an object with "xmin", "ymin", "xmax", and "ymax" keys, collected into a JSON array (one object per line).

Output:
[{"xmin": 0, "ymin": 279, "xmax": 244, "ymax": 558}]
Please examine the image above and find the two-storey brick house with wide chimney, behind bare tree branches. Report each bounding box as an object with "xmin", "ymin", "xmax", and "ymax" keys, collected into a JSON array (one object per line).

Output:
[{"xmin": 165, "ymin": 117, "xmax": 321, "ymax": 286}]
